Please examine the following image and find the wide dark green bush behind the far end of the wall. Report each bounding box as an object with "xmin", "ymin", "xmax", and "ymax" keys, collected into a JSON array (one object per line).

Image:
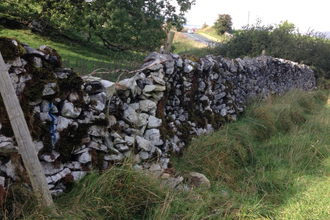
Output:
[{"xmin": 215, "ymin": 21, "xmax": 330, "ymax": 78}]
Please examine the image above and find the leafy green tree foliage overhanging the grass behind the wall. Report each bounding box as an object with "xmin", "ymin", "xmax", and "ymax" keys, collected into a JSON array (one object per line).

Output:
[{"xmin": 0, "ymin": 0, "xmax": 195, "ymax": 51}]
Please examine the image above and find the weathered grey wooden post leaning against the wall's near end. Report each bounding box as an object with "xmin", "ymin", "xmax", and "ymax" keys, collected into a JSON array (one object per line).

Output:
[{"xmin": 0, "ymin": 53, "xmax": 55, "ymax": 210}]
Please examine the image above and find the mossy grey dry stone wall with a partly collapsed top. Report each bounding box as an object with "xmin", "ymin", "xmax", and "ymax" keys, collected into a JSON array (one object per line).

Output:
[{"xmin": 0, "ymin": 38, "xmax": 316, "ymax": 192}]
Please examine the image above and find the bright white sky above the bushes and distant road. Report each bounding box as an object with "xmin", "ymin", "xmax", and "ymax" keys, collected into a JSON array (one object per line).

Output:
[{"xmin": 186, "ymin": 0, "xmax": 330, "ymax": 32}]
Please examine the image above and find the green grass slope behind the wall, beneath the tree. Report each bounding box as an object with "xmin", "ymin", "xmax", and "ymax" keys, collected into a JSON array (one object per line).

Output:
[{"xmin": 0, "ymin": 26, "xmax": 147, "ymax": 80}]
